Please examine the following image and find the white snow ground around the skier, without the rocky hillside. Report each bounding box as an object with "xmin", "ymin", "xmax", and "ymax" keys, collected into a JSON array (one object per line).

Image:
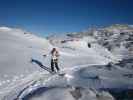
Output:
[{"xmin": 0, "ymin": 27, "xmax": 133, "ymax": 100}]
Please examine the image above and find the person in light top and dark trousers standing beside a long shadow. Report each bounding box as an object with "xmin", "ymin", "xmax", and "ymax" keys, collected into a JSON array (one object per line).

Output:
[{"xmin": 51, "ymin": 48, "xmax": 60, "ymax": 72}]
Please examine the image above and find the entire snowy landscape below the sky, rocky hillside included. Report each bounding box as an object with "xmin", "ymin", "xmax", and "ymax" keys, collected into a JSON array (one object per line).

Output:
[{"xmin": 0, "ymin": 25, "xmax": 133, "ymax": 100}]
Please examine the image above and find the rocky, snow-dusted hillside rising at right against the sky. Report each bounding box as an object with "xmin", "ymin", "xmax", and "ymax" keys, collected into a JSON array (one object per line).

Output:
[{"xmin": 65, "ymin": 24, "xmax": 133, "ymax": 58}]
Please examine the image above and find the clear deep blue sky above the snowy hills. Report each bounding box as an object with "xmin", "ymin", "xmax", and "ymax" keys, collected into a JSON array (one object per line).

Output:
[{"xmin": 0, "ymin": 0, "xmax": 133, "ymax": 36}]
